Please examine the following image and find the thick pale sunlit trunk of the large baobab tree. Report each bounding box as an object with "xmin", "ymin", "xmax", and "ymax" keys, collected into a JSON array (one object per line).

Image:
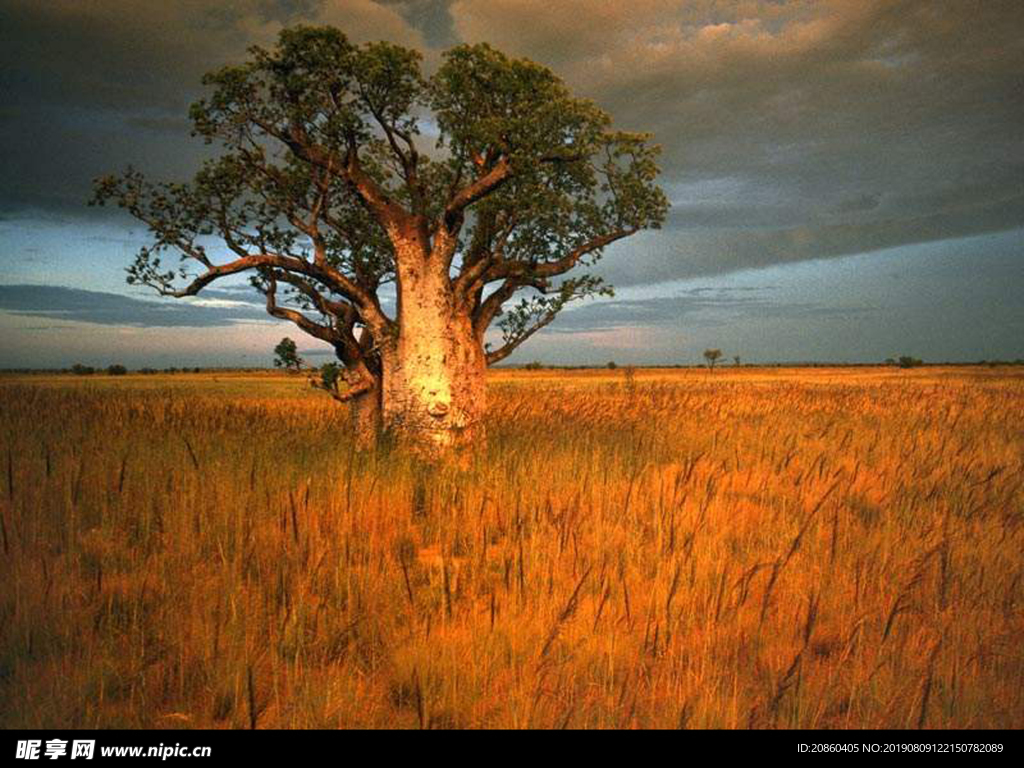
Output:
[{"xmin": 382, "ymin": 240, "xmax": 486, "ymax": 458}]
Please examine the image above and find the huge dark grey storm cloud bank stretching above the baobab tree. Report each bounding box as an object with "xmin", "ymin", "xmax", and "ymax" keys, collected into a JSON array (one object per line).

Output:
[{"xmin": 0, "ymin": 0, "xmax": 1024, "ymax": 285}]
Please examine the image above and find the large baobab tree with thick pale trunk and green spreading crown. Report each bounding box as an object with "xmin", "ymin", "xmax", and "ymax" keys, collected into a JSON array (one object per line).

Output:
[{"xmin": 95, "ymin": 27, "xmax": 668, "ymax": 455}]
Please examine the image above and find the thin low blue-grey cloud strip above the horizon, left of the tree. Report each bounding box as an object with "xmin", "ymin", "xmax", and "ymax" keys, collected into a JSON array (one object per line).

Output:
[{"xmin": 0, "ymin": 286, "xmax": 267, "ymax": 328}]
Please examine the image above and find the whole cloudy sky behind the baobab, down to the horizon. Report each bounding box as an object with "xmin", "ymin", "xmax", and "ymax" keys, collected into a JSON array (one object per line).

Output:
[{"xmin": 0, "ymin": 0, "xmax": 1024, "ymax": 368}]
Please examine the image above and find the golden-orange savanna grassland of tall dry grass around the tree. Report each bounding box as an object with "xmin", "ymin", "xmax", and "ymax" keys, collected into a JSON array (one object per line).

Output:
[{"xmin": 0, "ymin": 368, "xmax": 1024, "ymax": 728}]
